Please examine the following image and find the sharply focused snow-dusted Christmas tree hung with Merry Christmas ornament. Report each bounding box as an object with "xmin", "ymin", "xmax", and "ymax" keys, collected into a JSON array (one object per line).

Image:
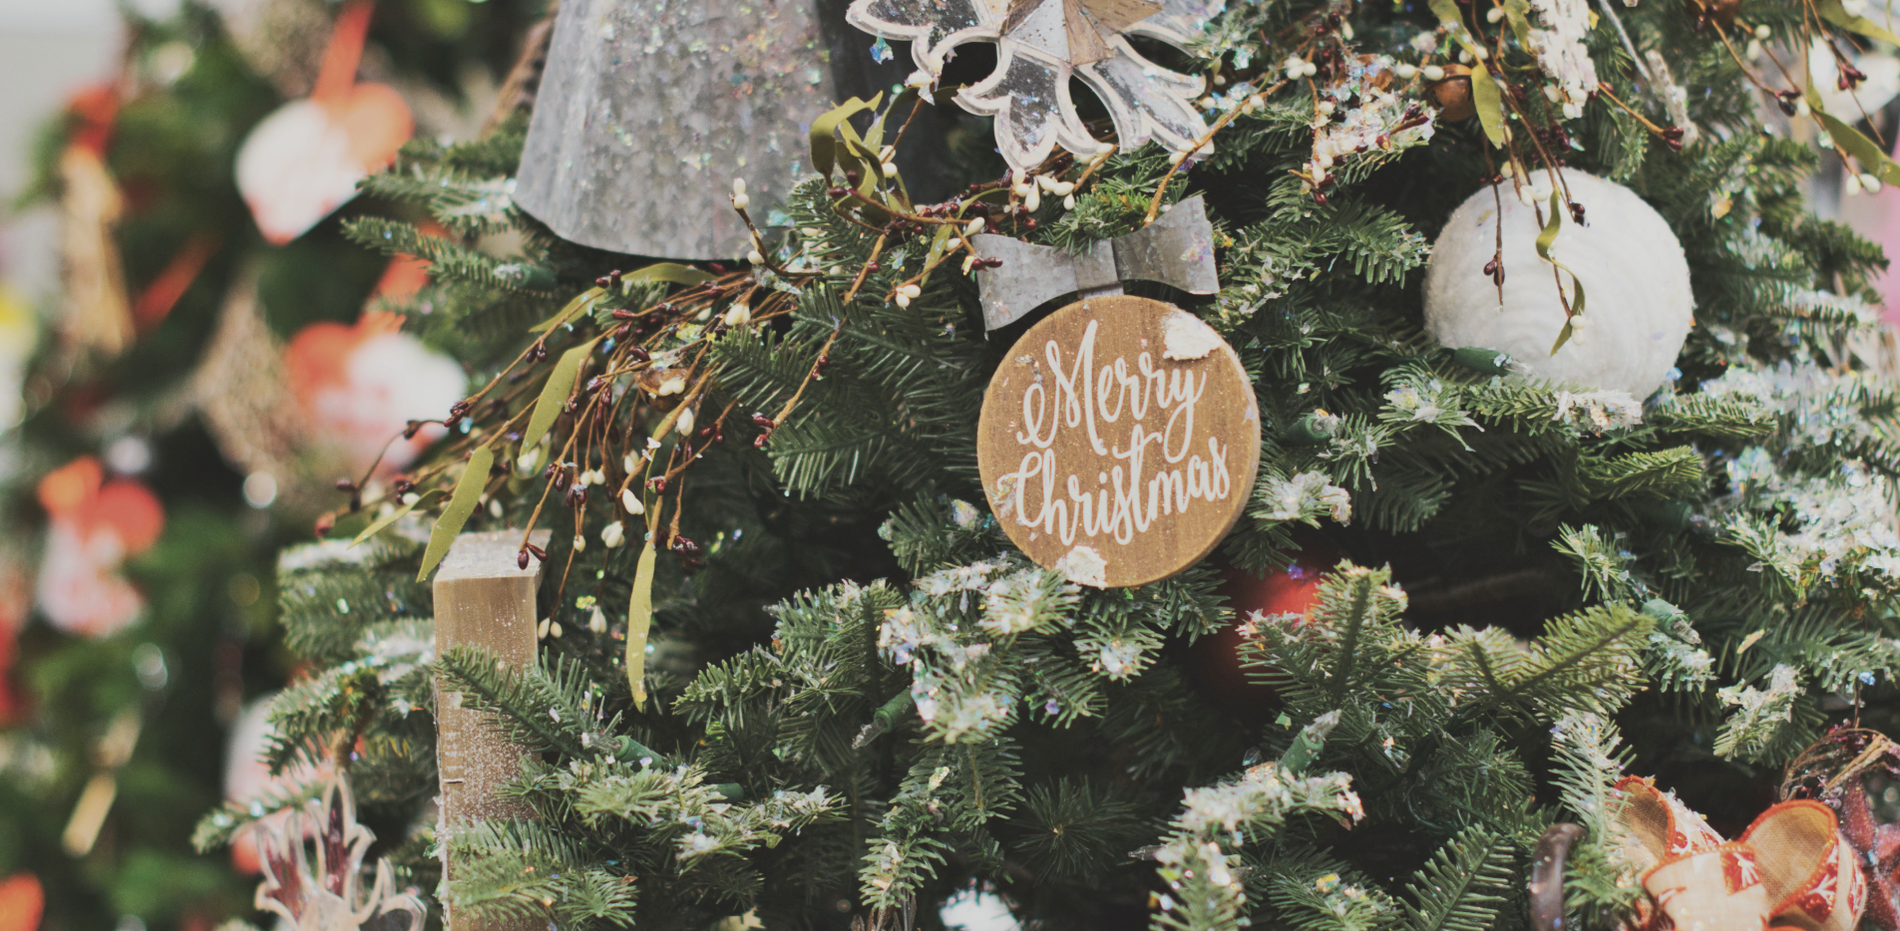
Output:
[{"xmin": 200, "ymin": 0, "xmax": 1900, "ymax": 929}]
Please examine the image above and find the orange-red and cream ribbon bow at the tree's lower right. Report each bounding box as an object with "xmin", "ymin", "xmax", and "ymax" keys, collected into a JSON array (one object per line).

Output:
[{"xmin": 1617, "ymin": 777, "xmax": 1868, "ymax": 931}]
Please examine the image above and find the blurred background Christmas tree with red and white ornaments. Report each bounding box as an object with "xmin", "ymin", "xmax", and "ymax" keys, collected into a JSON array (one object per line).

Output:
[{"xmin": 0, "ymin": 2, "xmax": 542, "ymax": 929}]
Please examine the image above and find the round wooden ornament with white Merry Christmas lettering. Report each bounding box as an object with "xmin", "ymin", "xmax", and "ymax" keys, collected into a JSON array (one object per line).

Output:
[{"xmin": 977, "ymin": 295, "xmax": 1260, "ymax": 587}]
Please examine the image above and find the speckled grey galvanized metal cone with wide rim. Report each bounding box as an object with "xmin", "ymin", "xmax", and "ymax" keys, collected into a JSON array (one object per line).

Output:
[{"xmin": 515, "ymin": 0, "xmax": 931, "ymax": 260}]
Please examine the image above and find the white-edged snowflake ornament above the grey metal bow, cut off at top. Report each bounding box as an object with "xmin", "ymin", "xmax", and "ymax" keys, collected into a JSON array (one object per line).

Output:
[{"xmin": 847, "ymin": 0, "xmax": 1227, "ymax": 171}]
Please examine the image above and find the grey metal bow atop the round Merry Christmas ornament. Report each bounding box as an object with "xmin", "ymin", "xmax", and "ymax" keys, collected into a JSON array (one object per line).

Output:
[{"xmin": 971, "ymin": 198, "xmax": 1220, "ymax": 331}]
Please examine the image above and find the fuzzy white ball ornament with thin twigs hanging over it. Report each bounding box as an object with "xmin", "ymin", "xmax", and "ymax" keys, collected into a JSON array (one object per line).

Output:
[{"xmin": 1425, "ymin": 169, "xmax": 1695, "ymax": 399}]
